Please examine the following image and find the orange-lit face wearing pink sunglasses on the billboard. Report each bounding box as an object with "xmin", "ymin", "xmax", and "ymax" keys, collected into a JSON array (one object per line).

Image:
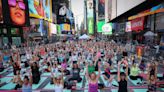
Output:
[{"xmin": 7, "ymin": 0, "xmax": 27, "ymax": 26}]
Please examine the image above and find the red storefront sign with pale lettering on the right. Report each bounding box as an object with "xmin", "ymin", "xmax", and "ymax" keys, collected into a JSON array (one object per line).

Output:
[{"xmin": 131, "ymin": 17, "xmax": 145, "ymax": 31}]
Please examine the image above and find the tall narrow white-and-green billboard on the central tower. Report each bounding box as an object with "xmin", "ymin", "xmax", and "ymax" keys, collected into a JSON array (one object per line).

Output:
[{"xmin": 87, "ymin": 0, "xmax": 94, "ymax": 34}]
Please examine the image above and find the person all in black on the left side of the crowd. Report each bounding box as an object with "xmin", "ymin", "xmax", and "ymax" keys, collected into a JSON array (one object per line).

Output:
[{"xmin": 31, "ymin": 62, "xmax": 40, "ymax": 84}]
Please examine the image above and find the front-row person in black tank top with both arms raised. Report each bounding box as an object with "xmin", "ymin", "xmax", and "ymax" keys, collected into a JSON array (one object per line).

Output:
[{"xmin": 117, "ymin": 61, "xmax": 128, "ymax": 92}]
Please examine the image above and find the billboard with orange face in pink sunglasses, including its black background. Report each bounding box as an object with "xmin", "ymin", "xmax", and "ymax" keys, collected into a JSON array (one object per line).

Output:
[{"xmin": 1, "ymin": 0, "xmax": 29, "ymax": 26}]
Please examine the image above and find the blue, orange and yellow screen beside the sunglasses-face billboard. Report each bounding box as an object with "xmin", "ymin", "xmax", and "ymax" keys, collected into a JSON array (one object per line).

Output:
[{"xmin": 28, "ymin": 0, "xmax": 52, "ymax": 21}]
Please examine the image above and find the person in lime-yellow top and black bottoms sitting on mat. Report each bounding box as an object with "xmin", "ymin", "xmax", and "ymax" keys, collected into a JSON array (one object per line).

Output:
[{"xmin": 129, "ymin": 61, "xmax": 143, "ymax": 84}]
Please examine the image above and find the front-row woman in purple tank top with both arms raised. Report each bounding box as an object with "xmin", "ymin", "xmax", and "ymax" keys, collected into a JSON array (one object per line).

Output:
[{"xmin": 86, "ymin": 62, "xmax": 101, "ymax": 92}]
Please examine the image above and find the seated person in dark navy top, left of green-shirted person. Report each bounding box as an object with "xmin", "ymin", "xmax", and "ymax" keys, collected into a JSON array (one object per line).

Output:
[{"xmin": 69, "ymin": 61, "xmax": 82, "ymax": 82}]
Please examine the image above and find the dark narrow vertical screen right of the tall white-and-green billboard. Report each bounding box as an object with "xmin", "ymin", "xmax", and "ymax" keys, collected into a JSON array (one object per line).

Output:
[{"xmin": 98, "ymin": 0, "xmax": 105, "ymax": 20}]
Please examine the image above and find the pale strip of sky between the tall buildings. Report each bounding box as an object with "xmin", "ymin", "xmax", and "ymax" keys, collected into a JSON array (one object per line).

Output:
[{"xmin": 71, "ymin": 0, "xmax": 84, "ymax": 29}]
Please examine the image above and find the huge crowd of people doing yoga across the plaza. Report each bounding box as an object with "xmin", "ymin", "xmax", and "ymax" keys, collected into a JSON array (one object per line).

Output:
[{"xmin": 0, "ymin": 41, "xmax": 164, "ymax": 92}]
